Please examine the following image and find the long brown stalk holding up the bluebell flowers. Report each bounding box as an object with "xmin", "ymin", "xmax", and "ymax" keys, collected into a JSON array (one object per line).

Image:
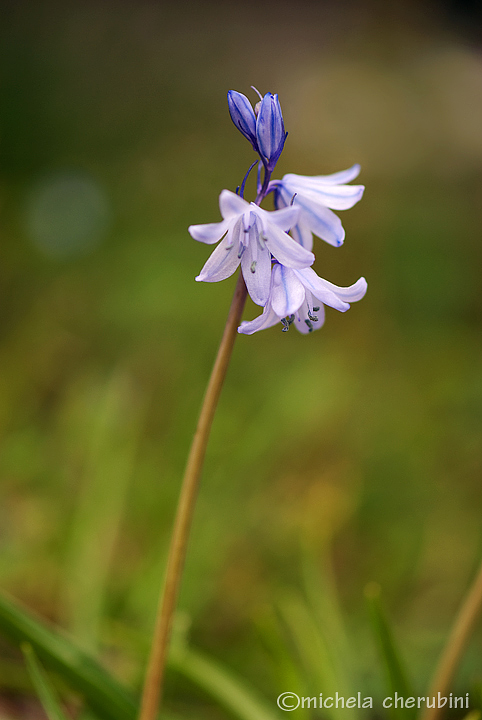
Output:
[{"xmin": 139, "ymin": 273, "xmax": 247, "ymax": 720}]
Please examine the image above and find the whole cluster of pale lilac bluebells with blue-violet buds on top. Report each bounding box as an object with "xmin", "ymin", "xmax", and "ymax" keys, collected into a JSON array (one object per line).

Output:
[{"xmin": 189, "ymin": 90, "xmax": 367, "ymax": 335}]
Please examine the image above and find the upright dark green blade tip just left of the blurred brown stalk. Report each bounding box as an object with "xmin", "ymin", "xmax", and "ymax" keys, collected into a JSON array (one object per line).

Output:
[{"xmin": 365, "ymin": 583, "xmax": 417, "ymax": 719}]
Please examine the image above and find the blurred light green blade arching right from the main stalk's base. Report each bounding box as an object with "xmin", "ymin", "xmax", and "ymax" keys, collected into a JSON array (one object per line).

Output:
[{"xmin": 169, "ymin": 644, "xmax": 277, "ymax": 720}]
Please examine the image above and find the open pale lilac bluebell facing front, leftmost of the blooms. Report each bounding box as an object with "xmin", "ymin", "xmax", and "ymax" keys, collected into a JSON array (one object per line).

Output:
[{"xmin": 189, "ymin": 190, "xmax": 315, "ymax": 305}]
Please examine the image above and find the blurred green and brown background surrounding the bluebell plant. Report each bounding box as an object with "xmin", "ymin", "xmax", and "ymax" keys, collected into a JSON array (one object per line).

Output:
[{"xmin": 0, "ymin": 0, "xmax": 482, "ymax": 718}]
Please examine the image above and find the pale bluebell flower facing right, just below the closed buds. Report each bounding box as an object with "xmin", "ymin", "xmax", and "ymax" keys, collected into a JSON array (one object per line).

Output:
[{"xmin": 269, "ymin": 165, "xmax": 365, "ymax": 250}]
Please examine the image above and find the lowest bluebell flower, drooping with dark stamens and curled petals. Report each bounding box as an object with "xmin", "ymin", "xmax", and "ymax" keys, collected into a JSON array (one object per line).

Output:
[{"xmin": 238, "ymin": 263, "xmax": 367, "ymax": 335}]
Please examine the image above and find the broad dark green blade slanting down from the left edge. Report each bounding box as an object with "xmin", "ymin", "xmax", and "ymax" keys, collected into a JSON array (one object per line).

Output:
[{"xmin": 0, "ymin": 594, "xmax": 137, "ymax": 720}]
